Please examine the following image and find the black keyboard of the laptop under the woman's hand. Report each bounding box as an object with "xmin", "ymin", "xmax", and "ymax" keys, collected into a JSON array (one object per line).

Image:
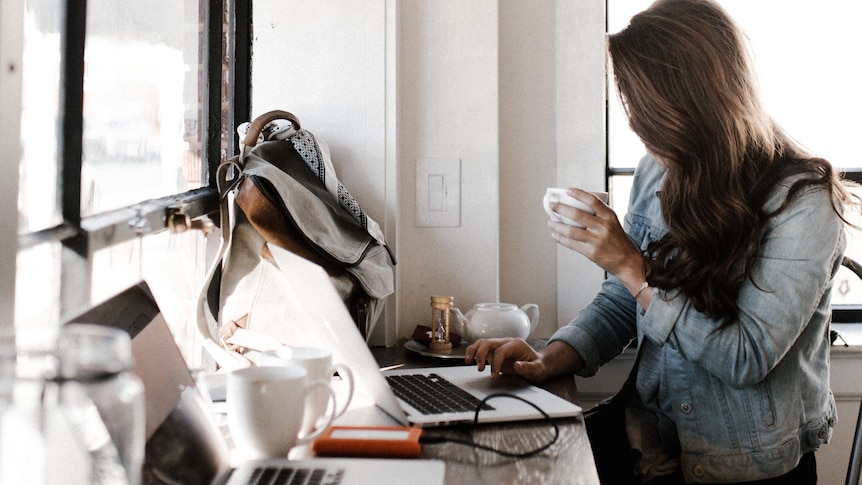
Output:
[{"xmin": 386, "ymin": 374, "xmax": 494, "ymax": 414}]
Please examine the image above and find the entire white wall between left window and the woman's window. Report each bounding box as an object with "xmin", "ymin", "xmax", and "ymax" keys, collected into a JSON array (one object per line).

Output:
[{"xmin": 252, "ymin": 0, "xmax": 605, "ymax": 344}]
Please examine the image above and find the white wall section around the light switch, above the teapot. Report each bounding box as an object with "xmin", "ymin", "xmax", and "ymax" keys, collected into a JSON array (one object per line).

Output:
[{"xmin": 396, "ymin": 0, "xmax": 501, "ymax": 334}]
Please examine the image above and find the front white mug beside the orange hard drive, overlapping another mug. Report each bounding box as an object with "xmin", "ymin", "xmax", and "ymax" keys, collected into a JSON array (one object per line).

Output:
[{"xmin": 227, "ymin": 366, "xmax": 334, "ymax": 459}]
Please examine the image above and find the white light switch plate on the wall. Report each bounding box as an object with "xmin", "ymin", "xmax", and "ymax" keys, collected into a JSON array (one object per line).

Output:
[{"xmin": 416, "ymin": 158, "xmax": 461, "ymax": 227}]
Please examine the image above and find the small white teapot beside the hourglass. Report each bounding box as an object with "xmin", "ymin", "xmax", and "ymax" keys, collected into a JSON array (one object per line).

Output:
[{"xmin": 452, "ymin": 303, "xmax": 539, "ymax": 342}]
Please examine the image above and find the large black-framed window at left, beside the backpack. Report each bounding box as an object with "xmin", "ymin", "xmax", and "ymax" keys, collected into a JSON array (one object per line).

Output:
[{"xmin": 15, "ymin": 0, "xmax": 250, "ymax": 360}]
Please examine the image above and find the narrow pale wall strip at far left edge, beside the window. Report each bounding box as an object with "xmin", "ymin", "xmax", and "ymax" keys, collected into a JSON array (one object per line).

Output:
[{"xmin": 0, "ymin": 0, "xmax": 24, "ymax": 333}]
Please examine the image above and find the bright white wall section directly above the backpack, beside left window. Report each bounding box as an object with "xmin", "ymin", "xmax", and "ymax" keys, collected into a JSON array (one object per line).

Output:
[{"xmin": 252, "ymin": 0, "xmax": 387, "ymax": 231}]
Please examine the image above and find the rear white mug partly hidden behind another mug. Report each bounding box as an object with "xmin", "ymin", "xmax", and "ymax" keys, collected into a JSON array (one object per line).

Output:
[{"xmin": 258, "ymin": 347, "xmax": 353, "ymax": 432}]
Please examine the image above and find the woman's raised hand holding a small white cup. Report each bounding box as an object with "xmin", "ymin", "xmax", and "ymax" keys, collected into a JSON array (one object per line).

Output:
[{"xmin": 548, "ymin": 188, "xmax": 644, "ymax": 294}]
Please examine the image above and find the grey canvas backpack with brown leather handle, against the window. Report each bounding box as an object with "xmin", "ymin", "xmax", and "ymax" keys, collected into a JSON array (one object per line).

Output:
[{"xmin": 197, "ymin": 110, "xmax": 395, "ymax": 366}]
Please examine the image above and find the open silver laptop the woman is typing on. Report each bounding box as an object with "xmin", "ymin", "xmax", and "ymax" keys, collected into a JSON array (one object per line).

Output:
[{"xmin": 224, "ymin": 246, "xmax": 582, "ymax": 427}]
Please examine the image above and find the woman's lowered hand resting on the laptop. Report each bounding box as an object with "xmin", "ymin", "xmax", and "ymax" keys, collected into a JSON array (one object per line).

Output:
[{"xmin": 464, "ymin": 338, "xmax": 550, "ymax": 382}]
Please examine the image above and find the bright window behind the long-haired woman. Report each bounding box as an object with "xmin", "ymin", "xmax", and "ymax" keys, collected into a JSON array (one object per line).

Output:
[{"xmin": 607, "ymin": 0, "xmax": 862, "ymax": 314}]
